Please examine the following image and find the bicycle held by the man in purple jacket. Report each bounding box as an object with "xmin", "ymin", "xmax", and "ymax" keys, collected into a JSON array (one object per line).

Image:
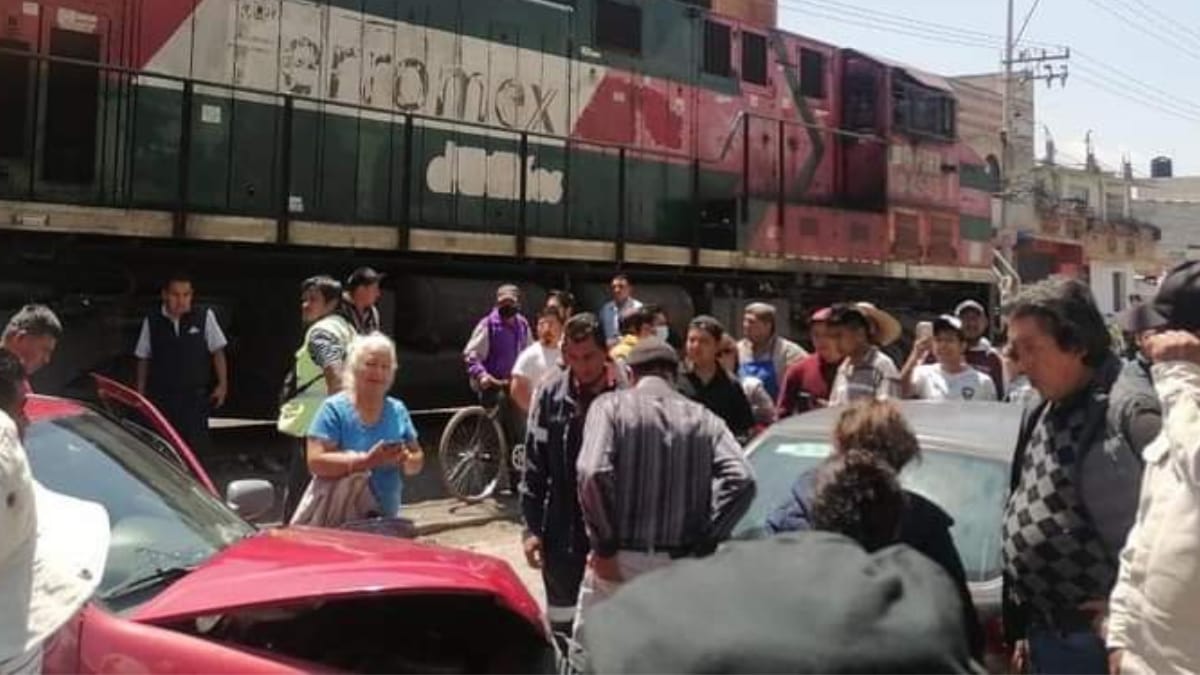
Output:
[{"xmin": 438, "ymin": 381, "xmax": 524, "ymax": 503}]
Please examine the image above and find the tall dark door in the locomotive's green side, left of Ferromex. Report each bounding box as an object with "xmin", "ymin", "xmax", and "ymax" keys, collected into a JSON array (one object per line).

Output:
[{"xmin": 42, "ymin": 29, "xmax": 100, "ymax": 184}]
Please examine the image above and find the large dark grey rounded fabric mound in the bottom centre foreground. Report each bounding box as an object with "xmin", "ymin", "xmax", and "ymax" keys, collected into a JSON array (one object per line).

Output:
[{"xmin": 581, "ymin": 532, "xmax": 983, "ymax": 673}]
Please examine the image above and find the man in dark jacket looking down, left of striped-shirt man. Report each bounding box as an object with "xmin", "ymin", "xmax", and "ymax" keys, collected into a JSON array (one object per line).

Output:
[{"xmin": 521, "ymin": 313, "xmax": 616, "ymax": 637}]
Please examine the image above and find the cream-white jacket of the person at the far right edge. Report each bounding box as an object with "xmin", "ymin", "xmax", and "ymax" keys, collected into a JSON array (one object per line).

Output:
[{"xmin": 1108, "ymin": 362, "xmax": 1200, "ymax": 673}]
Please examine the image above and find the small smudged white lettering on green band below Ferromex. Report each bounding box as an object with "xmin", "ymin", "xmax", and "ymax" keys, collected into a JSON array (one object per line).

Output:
[{"xmin": 425, "ymin": 141, "xmax": 563, "ymax": 204}]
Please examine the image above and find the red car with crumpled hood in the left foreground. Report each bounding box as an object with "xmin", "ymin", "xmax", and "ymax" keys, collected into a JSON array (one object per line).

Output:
[{"xmin": 25, "ymin": 378, "xmax": 553, "ymax": 673}]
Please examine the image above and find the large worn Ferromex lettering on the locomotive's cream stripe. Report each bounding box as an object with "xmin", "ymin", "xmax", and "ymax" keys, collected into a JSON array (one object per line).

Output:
[{"xmin": 224, "ymin": 0, "xmax": 569, "ymax": 135}]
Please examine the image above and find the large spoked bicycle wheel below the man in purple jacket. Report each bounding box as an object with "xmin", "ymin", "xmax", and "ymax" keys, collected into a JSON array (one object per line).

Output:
[{"xmin": 438, "ymin": 406, "xmax": 508, "ymax": 502}]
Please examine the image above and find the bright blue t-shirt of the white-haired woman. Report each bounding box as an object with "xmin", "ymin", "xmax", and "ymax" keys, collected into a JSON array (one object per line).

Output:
[{"xmin": 308, "ymin": 393, "xmax": 416, "ymax": 518}]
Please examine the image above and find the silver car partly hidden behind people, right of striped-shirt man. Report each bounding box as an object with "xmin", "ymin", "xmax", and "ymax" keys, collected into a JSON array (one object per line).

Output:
[{"xmin": 733, "ymin": 401, "xmax": 1022, "ymax": 670}]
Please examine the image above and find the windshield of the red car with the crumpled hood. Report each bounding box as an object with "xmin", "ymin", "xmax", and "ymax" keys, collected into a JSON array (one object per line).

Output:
[{"xmin": 25, "ymin": 411, "xmax": 254, "ymax": 611}]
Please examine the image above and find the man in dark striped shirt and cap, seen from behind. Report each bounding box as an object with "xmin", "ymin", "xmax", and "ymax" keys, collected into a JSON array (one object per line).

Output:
[{"xmin": 576, "ymin": 338, "xmax": 755, "ymax": 632}]
